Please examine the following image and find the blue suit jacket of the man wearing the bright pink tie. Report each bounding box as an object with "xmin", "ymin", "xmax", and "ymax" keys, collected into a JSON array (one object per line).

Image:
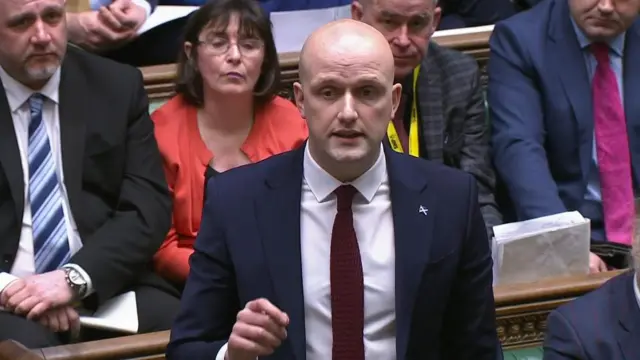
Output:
[{"xmin": 488, "ymin": 0, "xmax": 640, "ymax": 228}]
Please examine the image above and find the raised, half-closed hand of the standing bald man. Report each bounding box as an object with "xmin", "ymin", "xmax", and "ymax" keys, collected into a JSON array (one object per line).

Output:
[{"xmin": 226, "ymin": 299, "xmax": 289, "ymax": 360}]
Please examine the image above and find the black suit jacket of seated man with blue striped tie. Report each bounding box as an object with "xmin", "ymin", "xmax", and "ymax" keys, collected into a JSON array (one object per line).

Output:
[{"xmin": 0, "ymin": 47, "xmax": 171, "ymax": 303}]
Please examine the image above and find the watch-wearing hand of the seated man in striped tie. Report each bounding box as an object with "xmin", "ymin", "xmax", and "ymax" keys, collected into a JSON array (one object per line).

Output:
[{"xmin": 0, "ymin": 270, "xmax": 73, "ymax": 320}]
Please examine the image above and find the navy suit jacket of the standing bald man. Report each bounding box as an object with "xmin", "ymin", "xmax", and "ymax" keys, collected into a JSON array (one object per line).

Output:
[{"xmin": 167, "ymin": 147, "xmax": 501, "ymax": 360}]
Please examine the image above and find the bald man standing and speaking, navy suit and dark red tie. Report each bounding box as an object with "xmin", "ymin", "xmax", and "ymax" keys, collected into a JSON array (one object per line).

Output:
[{"xmin": 167, "ymin": 20, "xmax": 500, "ymax": 360}]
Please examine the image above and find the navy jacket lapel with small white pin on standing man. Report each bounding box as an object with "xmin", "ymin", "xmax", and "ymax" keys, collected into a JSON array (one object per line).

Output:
[{"xmin": 385, "ymin": 147, "xmax": 435, "ymax": 359}]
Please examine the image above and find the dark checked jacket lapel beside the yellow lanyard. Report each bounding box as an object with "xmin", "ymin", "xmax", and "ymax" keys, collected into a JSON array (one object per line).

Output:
[{"xmin": 414, "ymin": 50, "xmax": 445, "ymax": 162}]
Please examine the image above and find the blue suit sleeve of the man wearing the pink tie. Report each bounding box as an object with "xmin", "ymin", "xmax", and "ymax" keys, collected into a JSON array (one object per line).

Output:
[{"xmin": 488, "ymin": 24, "xmax": 566, "ymax": 220}]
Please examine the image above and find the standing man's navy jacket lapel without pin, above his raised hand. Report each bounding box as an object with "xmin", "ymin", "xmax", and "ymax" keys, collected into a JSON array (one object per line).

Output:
[{"xmin": 255, "ymin": 146, "xmax": 306, "ymax": 360}]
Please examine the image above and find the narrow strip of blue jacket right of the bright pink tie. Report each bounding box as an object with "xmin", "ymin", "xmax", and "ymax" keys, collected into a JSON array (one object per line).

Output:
[{"xmin": 622, "ymin": 20, "xmax": 640, "ymax": 184}]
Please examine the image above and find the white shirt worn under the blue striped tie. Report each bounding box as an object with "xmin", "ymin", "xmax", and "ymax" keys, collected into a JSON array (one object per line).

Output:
[{"xmin": 0, "ymin": 66, "xmax": 93, "ymax": 294}]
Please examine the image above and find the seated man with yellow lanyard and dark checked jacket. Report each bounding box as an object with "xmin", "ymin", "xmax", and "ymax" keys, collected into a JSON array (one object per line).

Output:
[{"xmin": 351, "ymin": 0, "xmax": 502, "ymax": 234}]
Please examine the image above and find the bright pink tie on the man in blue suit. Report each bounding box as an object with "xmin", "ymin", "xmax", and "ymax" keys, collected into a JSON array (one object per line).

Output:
[{"xmin": 591, "ymin": 43, "xmax": 635, "ymax": 245}]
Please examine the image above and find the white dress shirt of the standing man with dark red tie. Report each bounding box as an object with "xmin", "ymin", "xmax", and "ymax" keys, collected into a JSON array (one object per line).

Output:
[{"xmin": 216, "ymin": 147, "xmax": 396, "ymax": 360}]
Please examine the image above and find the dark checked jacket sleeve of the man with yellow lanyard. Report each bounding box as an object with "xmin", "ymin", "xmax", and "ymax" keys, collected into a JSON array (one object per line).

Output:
[{"xmin": 460, "ymin": 71, "xmax": 502, "ymax": 234}]
